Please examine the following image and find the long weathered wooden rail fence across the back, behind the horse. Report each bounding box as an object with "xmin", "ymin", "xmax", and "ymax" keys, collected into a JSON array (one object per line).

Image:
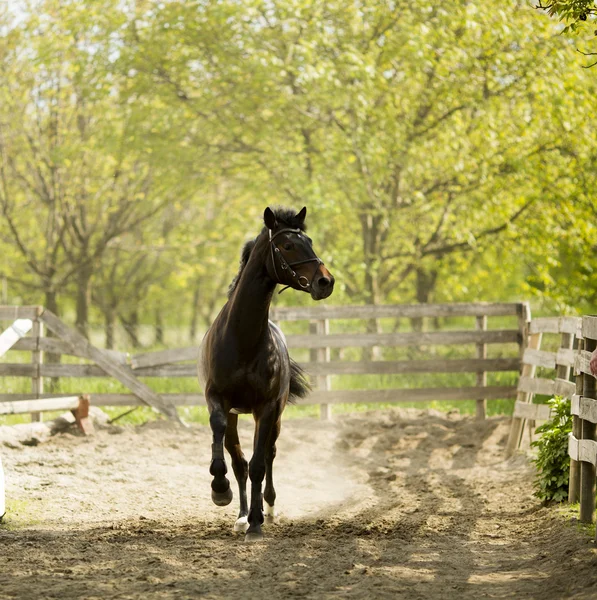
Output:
[{"xmin": 0, "ymin": 302, "xmax": 530, "ymax": 418}]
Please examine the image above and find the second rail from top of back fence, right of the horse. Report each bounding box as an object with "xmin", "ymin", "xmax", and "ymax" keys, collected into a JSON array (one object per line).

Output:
[{"xmin": 286, "ymin": 329, "xmax": 519, "ymax": 348}]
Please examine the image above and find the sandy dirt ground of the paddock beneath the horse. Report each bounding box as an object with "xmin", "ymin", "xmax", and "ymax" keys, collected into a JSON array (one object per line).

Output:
[{"xmin": 0, "ymin": 410, "xmax": 597, "ymax": 600}]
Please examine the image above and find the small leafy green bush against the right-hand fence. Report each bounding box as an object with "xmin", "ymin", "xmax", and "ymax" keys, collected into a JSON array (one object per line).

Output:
[{"xmin": 531, "ymin": 396, "xmax": 572, "ymax": 503}]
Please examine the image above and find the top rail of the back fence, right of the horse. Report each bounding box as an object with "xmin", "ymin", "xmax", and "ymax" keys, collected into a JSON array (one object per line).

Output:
[{"xmin": 270, "ymin": 302, "xmax": 521, "ymax": 321}]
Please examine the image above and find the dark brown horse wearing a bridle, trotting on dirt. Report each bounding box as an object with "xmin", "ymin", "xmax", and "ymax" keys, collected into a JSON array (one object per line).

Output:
[{"xmin": 199, "ymin": 207, "xmax": 334, "ymax": 542}]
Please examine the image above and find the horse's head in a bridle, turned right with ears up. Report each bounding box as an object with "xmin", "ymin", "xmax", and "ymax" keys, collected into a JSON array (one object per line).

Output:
[{"xmin": 263, "ymin": 207, "xmax": 334, "ymax": 300}]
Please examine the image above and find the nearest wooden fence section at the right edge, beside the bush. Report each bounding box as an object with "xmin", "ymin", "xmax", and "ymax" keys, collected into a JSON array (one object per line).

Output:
[{"xmin": 568, "ymin": 317, "xmax": 597, "ymax": 523}]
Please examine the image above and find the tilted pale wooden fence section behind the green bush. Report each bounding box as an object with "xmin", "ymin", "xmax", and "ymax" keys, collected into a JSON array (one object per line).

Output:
[{"xmin": 506, "ymin": 317, "xmax": 581, "ymax": 455}]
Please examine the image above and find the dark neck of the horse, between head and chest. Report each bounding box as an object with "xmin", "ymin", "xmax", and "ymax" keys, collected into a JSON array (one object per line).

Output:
[{"xmin": 228, "ymin": 243, "xmax": 276, "ymax": 348}]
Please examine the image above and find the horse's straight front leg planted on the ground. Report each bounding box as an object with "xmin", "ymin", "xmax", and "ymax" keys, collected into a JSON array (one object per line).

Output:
[{"xmin": 245, "ymin": 409, "xmax": 278, "ymax": 542}]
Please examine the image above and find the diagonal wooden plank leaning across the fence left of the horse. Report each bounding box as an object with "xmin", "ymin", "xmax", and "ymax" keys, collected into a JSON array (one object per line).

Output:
[{"xmin": 41, "ymin": 310, "xmax": 181, "ymax": 422}]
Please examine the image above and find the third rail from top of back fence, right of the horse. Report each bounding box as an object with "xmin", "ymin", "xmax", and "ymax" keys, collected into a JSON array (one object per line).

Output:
[{"xmin": 300, "ymin": 358, "xmax": 520, "ymax": 375}]
